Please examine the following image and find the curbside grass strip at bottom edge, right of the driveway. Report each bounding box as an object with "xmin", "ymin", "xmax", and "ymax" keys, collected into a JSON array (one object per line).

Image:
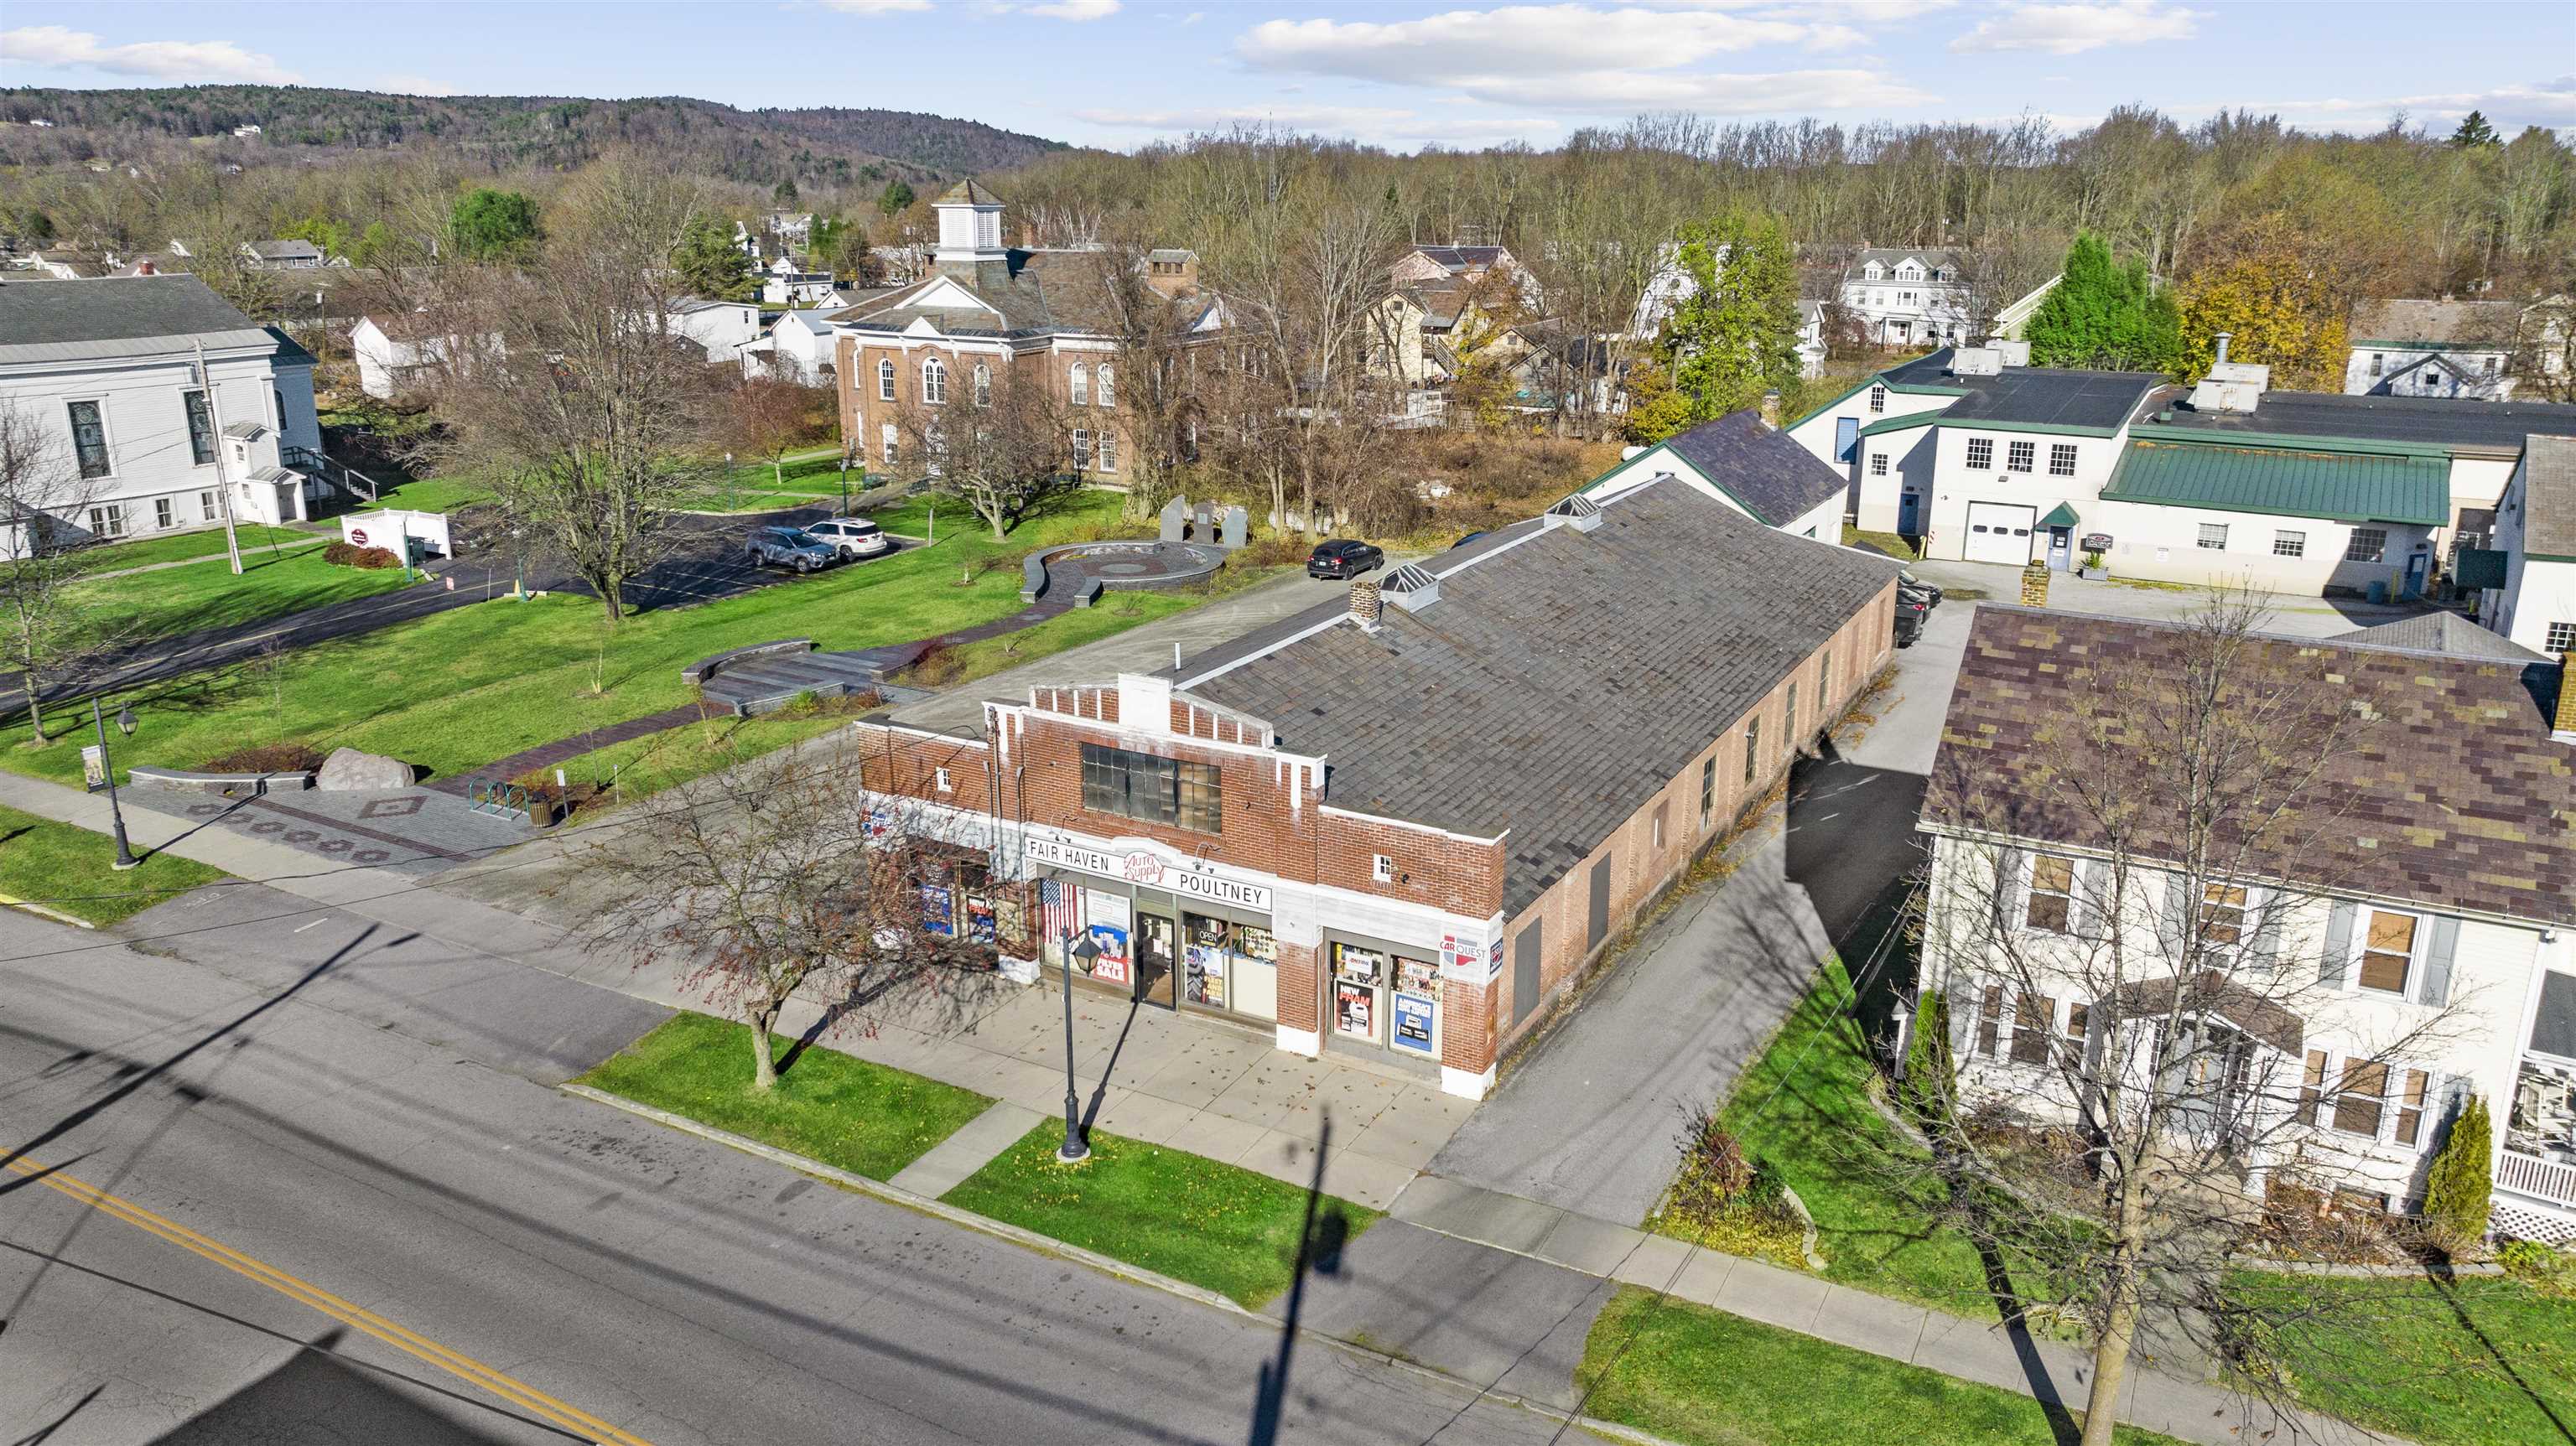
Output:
[{"xmin": 1576, "ymin": 1287, "xmax": 2179, "ymax": 1446}]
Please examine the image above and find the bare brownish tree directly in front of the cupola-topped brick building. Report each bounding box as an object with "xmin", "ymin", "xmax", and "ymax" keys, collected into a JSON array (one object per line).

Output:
[{"xmin": 894, "ymin": 358, "xmax": 1089, "ymax": 543}]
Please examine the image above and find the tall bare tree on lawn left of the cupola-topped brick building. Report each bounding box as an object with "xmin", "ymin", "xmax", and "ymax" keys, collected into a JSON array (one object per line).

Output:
[{"xmin": 428, "ymin": 162, "xmax": 719, "ymax": 623}]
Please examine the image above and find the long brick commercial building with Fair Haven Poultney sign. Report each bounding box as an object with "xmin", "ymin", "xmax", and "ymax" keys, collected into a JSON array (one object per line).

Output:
[{"xmin": 858, "ymin": 479, "xmax": 1896, "ymax": 1099}]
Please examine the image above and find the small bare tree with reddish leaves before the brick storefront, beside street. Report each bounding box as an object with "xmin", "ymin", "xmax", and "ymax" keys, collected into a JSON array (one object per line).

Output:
[{"xmin": 582, "ymin": 746, "xmax": 969, "ymax": 1091}]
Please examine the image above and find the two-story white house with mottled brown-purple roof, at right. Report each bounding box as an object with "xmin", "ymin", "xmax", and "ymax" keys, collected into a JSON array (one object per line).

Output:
[{"xmin": 1919, "ymin": 604, "xmax": 2576, "ymax": 1246}]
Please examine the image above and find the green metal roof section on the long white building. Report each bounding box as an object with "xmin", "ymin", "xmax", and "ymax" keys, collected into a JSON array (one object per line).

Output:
[{"xmin": 2102, "ymin": 440, "xmax": 2449, "ymax": 527}]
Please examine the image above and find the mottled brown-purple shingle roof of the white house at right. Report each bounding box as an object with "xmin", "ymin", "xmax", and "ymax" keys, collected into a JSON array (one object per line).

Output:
[{"xmin": 1924, "ymin": 602, "xmax": 2576, "ymax": 924}]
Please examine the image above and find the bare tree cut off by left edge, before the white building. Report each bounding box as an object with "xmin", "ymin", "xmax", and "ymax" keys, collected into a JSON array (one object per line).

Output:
[{"xmin": 0, "ymin": 402, "xmax": 123, "ymax": 744}]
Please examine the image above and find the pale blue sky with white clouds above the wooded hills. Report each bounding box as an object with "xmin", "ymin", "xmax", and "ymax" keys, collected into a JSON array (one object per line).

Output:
[{"xmin": 0, "ymin": 0, "xmax": 2576, "ymax": 149}]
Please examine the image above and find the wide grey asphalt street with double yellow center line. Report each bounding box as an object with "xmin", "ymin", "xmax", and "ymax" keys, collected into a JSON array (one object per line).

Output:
[{"xmin": 0, "ymin": 885, "xmax": 1597, "ymax": 1446}]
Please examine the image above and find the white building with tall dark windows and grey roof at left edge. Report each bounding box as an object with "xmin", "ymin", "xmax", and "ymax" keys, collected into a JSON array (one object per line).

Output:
[{"xmin": 0, "ymin": 275, "xmax": 325, "ymax": 543}]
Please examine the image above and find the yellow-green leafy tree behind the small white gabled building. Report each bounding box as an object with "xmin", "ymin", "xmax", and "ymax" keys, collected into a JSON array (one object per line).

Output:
[{"xmin": 1656, "ymin": 211, "xmax": 1798, "ymax": 435}]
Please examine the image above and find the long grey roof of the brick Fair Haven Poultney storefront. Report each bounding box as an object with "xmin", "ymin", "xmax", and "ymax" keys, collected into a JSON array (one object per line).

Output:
[{"xmin": 1167, "ymin": 479, "xmax": 1896, "ymax": 916}]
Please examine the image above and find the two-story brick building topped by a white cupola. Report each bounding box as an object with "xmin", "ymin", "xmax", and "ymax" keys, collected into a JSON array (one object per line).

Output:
[{"xmin": 829, "ymin": 180, "xmax": 1223, "ymax": 486}]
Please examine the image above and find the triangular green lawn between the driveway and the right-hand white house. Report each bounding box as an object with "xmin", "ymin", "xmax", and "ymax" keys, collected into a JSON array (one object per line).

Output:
[{"xmin": 1721, "ymin": 960, "xmax": 2050, "ymax": 1320}]
